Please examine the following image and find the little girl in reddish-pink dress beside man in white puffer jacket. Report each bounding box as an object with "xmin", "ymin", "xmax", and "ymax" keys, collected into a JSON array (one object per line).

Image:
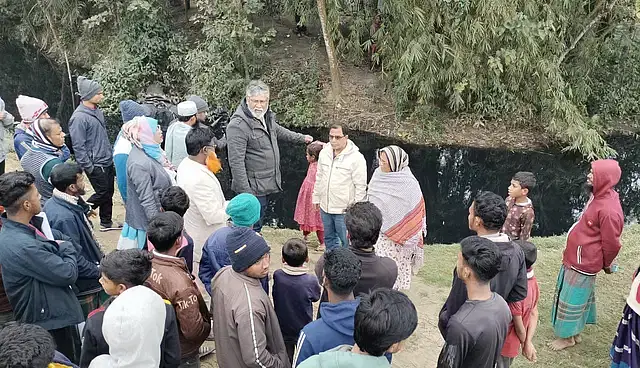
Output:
[{"xmin": 293, "ymin": 141, "xmax": 325, "ymax": 252}]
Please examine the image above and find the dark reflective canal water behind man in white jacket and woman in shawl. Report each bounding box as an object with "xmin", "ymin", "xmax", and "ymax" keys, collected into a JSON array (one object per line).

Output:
[{"xmin": 220, "ymin": 129, "xmax": 640, "ymax": 243}]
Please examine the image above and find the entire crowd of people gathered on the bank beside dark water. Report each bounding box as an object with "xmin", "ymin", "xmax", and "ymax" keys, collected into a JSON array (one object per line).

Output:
[{"xmin": 0, "ymin": 77, "xmax": 640, "ymax": 368}]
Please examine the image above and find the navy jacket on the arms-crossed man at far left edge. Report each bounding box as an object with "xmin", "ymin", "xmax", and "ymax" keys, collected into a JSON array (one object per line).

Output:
[{"xmin": 0, "ymin": 218, "xmax": 84, "ymax": 330}]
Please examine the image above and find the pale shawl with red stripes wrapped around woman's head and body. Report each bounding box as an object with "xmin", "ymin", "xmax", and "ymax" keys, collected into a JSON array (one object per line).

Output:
[{"xmin": 367, "ymin": 146, "xmax": 427, "ymax": 248}]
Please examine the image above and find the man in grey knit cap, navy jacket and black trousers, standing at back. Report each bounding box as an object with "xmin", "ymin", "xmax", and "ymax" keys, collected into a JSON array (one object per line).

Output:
[{"xmin": 69, "ymin": 76, "xmax": 122, "ymax": 231}]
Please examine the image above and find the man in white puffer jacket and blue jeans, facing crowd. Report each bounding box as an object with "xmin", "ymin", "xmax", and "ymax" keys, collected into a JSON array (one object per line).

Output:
[{"xmin": 313, "ymin": 124, "xmax": 367, "ymax": 250}]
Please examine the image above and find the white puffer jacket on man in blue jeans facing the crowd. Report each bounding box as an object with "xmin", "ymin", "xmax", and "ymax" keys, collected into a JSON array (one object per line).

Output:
[{"xmin": 313, "ymin": 140, "xmax": 367, "ymax": 215}]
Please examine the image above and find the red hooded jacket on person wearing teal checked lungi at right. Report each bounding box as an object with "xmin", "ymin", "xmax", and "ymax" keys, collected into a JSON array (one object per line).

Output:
[{"xmin": 562, "ymin": 160, "xmax": 624, "ymax": 274}]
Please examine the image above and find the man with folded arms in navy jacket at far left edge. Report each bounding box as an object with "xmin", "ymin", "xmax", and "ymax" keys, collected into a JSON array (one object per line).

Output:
[{"xmin": 0, "ymin": 171, "xmax": 84, "ymax": 362}]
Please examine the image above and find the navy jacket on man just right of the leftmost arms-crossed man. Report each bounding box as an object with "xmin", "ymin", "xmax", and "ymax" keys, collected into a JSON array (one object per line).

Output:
[{"xmin": 43, "ymin": 196, "xmax": 102, "ymax": 296}]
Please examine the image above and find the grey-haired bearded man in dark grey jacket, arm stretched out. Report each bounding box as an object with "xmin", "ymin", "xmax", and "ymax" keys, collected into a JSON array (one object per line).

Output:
[{"xmin": 227, "ymin": 81, "xmax": 313, "ymax": 232}]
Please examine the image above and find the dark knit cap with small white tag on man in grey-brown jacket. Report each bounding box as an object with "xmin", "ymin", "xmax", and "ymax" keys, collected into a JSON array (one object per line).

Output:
[{"xmin": 227, "ymin": 227, "xmax": 271, "ymax": 272}]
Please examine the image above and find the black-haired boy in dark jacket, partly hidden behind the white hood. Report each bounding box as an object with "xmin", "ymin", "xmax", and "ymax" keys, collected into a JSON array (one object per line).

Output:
[{"xmin": 80, "ymin": 249, "xmax": 180, "ymax": 368}]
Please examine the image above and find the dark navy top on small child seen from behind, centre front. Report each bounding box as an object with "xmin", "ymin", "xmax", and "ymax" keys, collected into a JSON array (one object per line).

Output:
[{"xmin": 272, "ymin": 270, "xmax": 320, "ymax": 344}]
